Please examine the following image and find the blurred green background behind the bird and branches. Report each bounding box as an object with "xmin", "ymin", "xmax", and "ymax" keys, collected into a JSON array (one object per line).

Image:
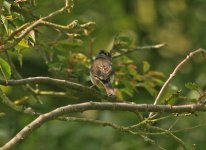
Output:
[{"xmin": 0, "ymin": 0, "xmax": 206, "ymax": 150}]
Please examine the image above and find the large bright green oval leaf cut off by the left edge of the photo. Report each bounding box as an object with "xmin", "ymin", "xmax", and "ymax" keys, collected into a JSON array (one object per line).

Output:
[{"xmin": 0, "ymin": 58, "xmax": 11, "ymax": 80}]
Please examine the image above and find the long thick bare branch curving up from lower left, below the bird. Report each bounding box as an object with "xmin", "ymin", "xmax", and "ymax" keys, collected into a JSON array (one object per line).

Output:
[{"xmin": 0, "ymin": 102, "xmax": 206, "ymax": 150}]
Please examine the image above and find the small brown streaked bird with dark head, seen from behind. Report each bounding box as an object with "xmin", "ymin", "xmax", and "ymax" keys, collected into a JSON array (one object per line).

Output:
[{"xmin": 90, "ymin": 50, "xmax": 115, "ymax": 96}]
